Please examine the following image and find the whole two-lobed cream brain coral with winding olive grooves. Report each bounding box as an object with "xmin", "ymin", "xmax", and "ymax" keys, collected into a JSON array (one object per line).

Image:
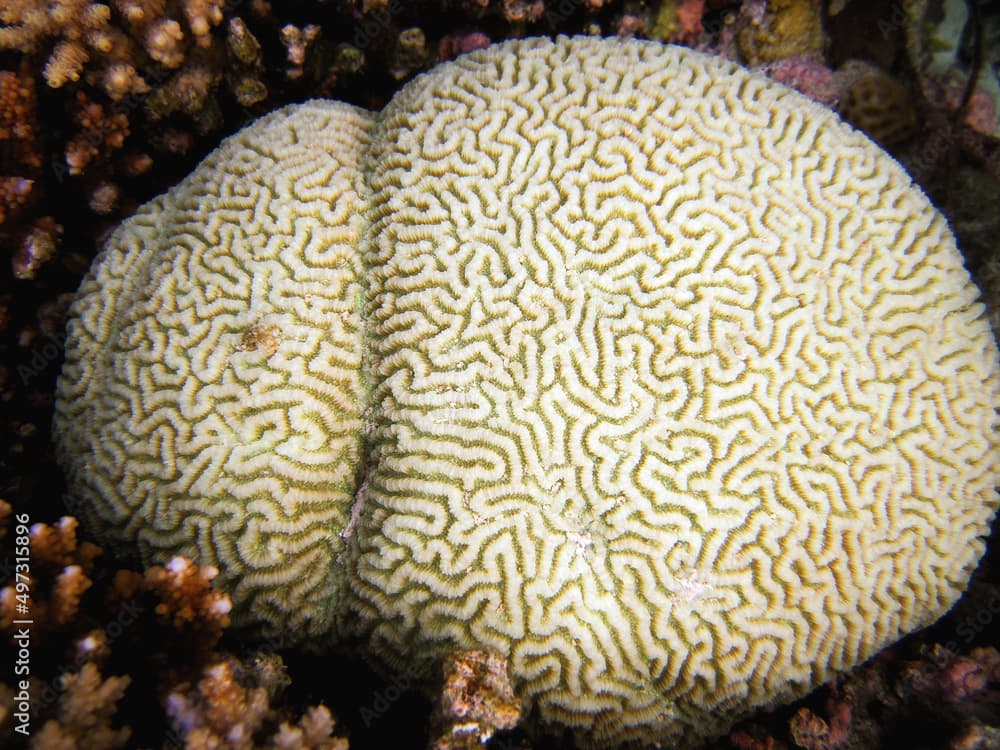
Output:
[{"xmin": 55, "ymin": 38, "xmax": 1000, "ymax": 745}]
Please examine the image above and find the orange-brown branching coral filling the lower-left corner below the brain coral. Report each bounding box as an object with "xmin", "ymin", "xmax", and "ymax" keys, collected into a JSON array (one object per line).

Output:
[{"xmin": 0, "ymin": 500, "xmax": 356, "ymax": 750}]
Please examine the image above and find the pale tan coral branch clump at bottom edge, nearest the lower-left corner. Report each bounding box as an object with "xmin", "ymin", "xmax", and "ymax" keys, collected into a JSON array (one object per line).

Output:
[{"xmin": 31, "ymin": 662, "xmax": 132, "ymax": 750}]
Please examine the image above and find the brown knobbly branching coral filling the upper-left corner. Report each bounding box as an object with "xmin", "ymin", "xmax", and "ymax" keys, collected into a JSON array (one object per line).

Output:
[{"xmin": 0, "ymin": 0, "xmax": 242, "ymax": 250}]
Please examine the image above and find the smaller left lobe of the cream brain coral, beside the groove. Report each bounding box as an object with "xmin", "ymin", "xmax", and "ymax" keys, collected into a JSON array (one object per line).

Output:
[{"xmin": 56, "ymin": 102, "xmax": 370, "ymax": 637}]
